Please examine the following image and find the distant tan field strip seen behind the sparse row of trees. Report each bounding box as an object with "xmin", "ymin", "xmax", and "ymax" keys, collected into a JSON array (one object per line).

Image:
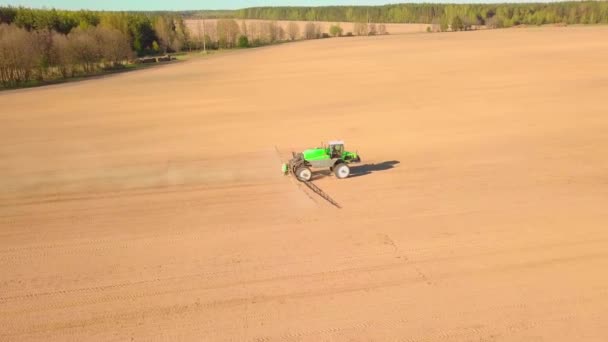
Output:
[{"xmin": 186, "ymin": 19, "xmax": 432, "ymax": 36}]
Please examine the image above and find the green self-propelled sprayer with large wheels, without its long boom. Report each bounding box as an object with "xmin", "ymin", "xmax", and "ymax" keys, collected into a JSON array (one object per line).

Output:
[{"xmin": 283, "ymin": 141, "xmax": 361, "ymax": 182}]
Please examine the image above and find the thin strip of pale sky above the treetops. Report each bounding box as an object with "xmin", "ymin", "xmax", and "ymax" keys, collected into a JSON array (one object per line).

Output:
[{"xmin": 0, "ymin": 0, "xmax": 556, "ymax": 11}]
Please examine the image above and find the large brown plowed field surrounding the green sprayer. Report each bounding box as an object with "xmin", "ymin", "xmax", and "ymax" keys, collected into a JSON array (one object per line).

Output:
[{"xmin": 0, "ymin": 27, "xmax": 608, "ymax": 342}]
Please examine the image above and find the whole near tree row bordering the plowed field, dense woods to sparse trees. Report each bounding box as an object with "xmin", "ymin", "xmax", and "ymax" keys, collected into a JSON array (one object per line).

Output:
[{"xmin": 0, "ymin": 7, "xmax": 386, "ymax": 87}]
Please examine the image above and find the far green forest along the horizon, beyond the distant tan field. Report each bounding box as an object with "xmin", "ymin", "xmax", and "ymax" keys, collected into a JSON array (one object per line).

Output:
[{"xmin": 184, "ymin": 1, "xmax": 608, "ymax": 28}]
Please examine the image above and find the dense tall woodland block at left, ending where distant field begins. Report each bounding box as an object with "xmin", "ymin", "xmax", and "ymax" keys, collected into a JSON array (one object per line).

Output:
[{"xmin": 0, "ymin": 7, "xmax": 191, "ymax": 87}]
